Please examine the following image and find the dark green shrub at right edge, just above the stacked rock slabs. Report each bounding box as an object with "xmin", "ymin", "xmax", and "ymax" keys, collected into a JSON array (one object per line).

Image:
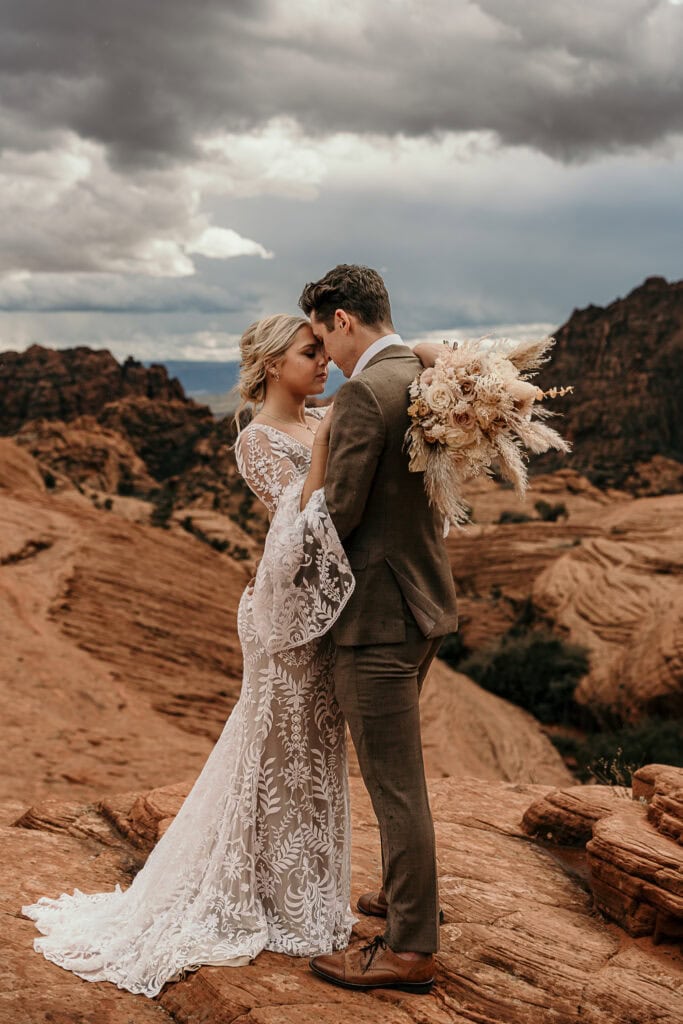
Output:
[{"xmin": 569, "ymin": 718, "xmax": 683, "ymax": 785}]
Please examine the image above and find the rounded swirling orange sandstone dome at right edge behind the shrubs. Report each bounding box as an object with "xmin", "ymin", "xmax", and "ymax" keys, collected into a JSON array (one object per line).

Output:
[{"xmin": 532, "ymin": 495, "xmax": 683, "ymax": 720}]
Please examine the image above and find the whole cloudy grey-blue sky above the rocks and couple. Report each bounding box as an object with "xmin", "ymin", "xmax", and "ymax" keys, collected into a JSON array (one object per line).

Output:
[{"xmin": 0, "ymin": 0, "xmax": 683, "ymax": 359}]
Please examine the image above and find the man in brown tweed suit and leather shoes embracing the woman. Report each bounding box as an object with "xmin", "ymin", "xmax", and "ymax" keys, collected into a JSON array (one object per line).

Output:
[{"xmin": 299, "ymin": 264, "xmax": 458, "ymax": 992}]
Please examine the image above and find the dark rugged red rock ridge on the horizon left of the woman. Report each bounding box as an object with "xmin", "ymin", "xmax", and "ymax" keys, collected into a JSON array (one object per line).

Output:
[{"xmin": 0, "ymin": 346, "xmax": 267, "ymax": 542}]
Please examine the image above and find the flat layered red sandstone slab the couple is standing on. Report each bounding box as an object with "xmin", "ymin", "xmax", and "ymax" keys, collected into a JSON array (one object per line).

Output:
[{"xmin": 6, "ymin": 778, "xmax": 683, "ymax": 1024}]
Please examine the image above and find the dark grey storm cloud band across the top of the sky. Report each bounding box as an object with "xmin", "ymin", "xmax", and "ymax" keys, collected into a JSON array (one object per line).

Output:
[{"xmin": 0, "ymin": 0, "xmax": 683, "ymax": 165}]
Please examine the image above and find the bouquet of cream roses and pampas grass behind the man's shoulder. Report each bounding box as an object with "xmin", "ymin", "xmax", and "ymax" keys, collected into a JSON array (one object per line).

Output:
[{"xmin": 405, "ymin": 338, "xmax": 573, "ymax": 525}]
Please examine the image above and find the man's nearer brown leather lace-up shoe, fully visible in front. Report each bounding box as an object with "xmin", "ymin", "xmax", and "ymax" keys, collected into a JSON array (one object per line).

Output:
[{"xmin": 308, "ymin": 935, "xmax": 434, "ymax": 995}]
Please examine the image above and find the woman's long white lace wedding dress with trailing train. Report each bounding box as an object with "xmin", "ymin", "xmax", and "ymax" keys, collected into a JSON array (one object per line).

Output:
[{"xmin": 23, "ymin": 413, "xmax": 354, "ymax": 996}]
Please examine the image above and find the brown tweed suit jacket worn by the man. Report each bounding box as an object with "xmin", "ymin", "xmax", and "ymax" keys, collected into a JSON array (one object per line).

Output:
[{"xmin": 325, "ymin": 345, "xmax": 458, "ymax": 646}]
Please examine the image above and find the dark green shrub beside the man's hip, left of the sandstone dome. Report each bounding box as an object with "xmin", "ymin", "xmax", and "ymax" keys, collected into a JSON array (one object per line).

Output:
[{"xmin": 459, "ymin": 630, "xmax": 589, "ymax": 723}]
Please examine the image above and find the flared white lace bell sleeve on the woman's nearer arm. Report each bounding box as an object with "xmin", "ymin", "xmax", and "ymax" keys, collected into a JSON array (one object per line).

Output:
[{"xmin": 238, "ymin": 430, "xmax": 355, "ymax": 654}]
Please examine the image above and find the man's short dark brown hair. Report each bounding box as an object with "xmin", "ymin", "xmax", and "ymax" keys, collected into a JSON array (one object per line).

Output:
[{"xmin": 299, "ymin": 263, "xmax": 392, "ymax": 331}]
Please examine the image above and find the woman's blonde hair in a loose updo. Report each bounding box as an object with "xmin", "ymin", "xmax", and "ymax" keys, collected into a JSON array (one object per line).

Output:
[{"xmin": 234, "ymin": 313, "xmax": 308, "ymax": 430}]
